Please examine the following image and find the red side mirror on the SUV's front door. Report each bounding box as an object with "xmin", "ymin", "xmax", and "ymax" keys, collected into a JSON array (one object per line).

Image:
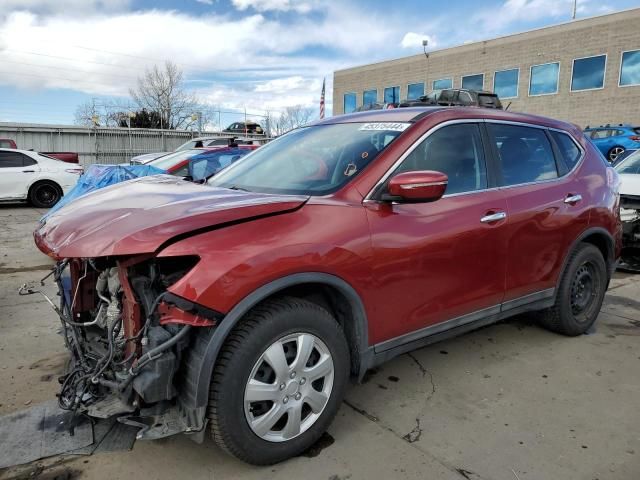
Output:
[{"xmin": 383, "ymin": 170, "xmax": 449, "ymax": 202}]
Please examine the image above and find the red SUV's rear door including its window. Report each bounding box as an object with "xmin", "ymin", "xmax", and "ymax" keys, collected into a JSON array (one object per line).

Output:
[{"xmin": 487, "ymin": 122, "xmax": 589, "ymax": 307}]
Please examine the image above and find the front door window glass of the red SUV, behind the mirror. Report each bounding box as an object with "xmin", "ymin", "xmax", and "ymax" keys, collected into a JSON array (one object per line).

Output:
[{"xmin": 396, "ymin": 123, "xmax": 487, "ymax": 195}]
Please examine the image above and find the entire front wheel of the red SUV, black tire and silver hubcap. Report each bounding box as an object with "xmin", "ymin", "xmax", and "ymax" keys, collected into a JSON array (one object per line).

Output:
[{"xmin": 207, "ymin": 297, "xmax": 350, "ymax": 465}]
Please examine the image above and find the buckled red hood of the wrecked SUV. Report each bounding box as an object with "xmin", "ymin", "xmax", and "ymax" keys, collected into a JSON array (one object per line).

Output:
[{"xmin": 34, "ymin": 175, "xmax": 308, "ymax": 258}]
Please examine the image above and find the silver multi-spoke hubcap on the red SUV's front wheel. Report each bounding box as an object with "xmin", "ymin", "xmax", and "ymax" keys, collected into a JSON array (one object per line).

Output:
[{"xmin": 244, "ymin": 332, "xmax": 334, "ymax": 442}]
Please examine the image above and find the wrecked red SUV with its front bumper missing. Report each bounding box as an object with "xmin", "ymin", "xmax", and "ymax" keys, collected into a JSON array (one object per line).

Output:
[{"xmin": 35, "ymin": 107, "xmax": 621, "ymax": 464}]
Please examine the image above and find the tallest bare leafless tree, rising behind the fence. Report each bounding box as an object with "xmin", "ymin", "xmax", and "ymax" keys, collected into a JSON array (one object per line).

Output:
[{"xmin": 129, "ymin": 61, "xmax": 204, "ymax": 129}]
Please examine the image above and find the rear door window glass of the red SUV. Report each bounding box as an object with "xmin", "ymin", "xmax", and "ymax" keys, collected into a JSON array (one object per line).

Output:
[{"xmin": 487, "ymin": 123, "xmax": 558, "ymax": 186}]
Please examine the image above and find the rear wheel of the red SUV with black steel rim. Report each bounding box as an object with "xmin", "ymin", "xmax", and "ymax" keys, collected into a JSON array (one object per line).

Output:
[{"xmin": 538, "ymin": 243, "xmax": 608, "ymax": 336}]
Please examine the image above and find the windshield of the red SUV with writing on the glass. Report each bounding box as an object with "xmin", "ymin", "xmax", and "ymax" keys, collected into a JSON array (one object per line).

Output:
[{"xmin": 208, "ymin": 122, "xmax": 410, "ymax": 195}]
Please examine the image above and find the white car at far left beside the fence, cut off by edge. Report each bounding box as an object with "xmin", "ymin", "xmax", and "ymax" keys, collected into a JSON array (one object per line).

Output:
[{"xmin": 0, "ymin": 148, "xmax": 83, "ymax": 208}]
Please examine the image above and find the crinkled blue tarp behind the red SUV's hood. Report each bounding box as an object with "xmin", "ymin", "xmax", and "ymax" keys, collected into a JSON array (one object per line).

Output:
[{"xmin": 42, "ymin": 165, "xmax": 167, "ymax": 218}]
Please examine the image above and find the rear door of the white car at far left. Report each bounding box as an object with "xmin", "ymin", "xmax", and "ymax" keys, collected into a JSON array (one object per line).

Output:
[{"xmin": 0, "ymin": 150, "xmax": 40, "ymax": 200}]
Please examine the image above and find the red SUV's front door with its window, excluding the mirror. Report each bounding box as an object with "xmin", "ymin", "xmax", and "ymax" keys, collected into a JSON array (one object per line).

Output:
[{"xmin": 365, "ymin": 123, "xmax": 507, "ymax": 349}]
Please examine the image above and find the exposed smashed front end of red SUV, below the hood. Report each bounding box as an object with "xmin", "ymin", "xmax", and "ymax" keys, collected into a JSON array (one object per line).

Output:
[{"xmin": 22, "ymin": 255, "xmax": 222, "ymax": 438}]
